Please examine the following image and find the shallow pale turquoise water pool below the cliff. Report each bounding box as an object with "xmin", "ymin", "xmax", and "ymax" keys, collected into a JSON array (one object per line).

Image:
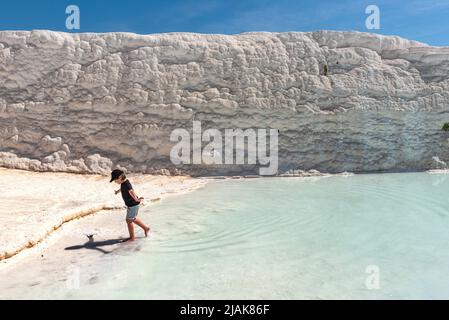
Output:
[{"xmin": 0, "ymin": 173, "xmax": 449, "ymax": 299}]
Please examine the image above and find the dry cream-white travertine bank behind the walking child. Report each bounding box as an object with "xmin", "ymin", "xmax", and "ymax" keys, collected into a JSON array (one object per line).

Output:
[{"xmin": 0, "ymin": 168, "xmax": 206, "ymax": 260}]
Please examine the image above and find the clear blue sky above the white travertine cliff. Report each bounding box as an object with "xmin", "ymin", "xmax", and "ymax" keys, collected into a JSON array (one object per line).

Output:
[{"xmin": 0, "ymin": 0, "xmax": 449, "ymax": 46}]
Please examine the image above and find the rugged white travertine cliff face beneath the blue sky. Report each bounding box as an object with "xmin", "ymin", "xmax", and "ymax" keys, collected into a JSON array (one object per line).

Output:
[{"xmin": 0, "ymin": 31, "xmax": 449, "ymax": 174}]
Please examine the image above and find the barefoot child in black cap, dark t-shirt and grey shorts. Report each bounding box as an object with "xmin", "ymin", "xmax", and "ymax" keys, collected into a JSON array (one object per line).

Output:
[{"xmin": 110, "ymin": 169, "xmax": 150, "ymax": 241}]
